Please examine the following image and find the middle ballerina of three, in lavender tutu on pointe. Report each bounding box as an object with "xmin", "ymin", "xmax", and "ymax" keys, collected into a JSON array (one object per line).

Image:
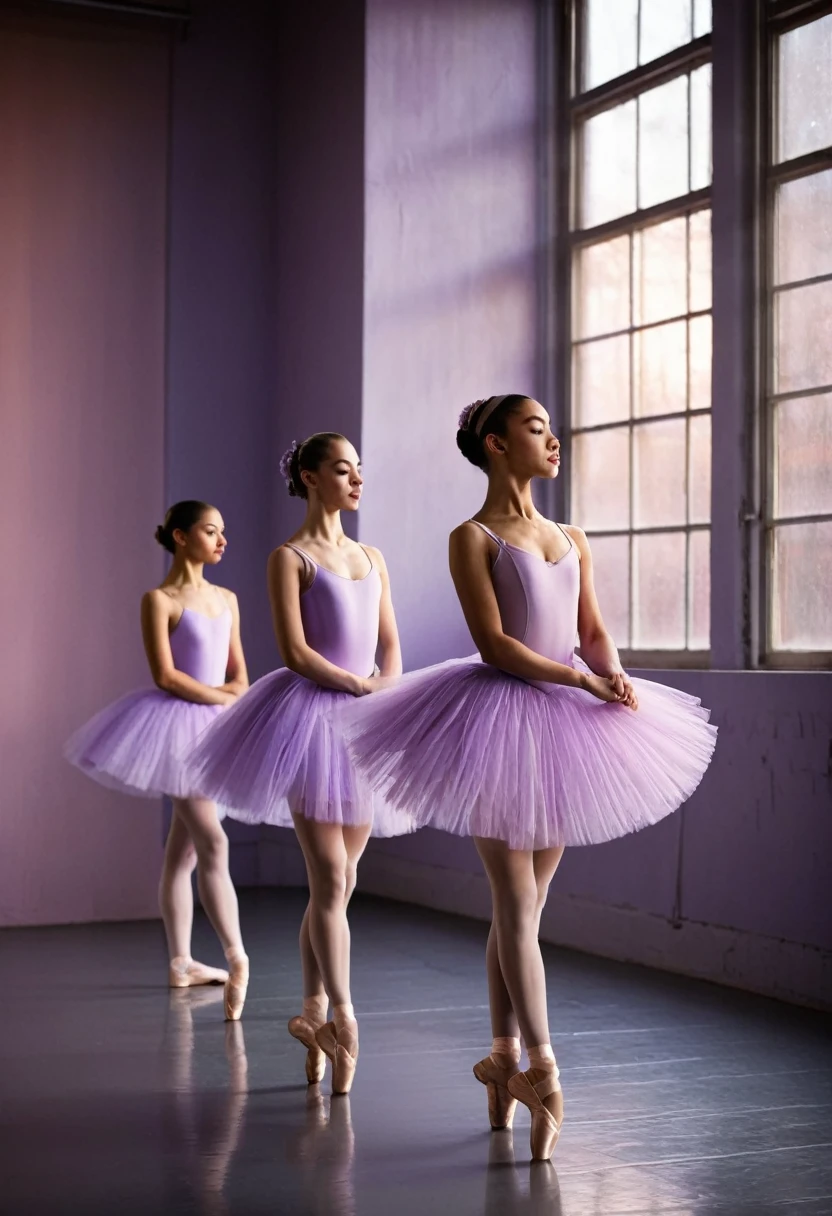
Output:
[{"xmin": 190, "ymin": 433, "xmax": 410, "ymax": 1093}]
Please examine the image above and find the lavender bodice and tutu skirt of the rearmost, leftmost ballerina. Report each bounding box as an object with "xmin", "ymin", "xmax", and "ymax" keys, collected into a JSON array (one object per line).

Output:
[{"xmin": 64, "ymin": 608, "xmax": 231, "ymax": 798}]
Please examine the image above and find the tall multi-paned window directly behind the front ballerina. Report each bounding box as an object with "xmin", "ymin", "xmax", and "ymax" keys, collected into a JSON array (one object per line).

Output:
[{"xmin": 567, "ymin": 0, "xmax": 710, "ymax": 664}]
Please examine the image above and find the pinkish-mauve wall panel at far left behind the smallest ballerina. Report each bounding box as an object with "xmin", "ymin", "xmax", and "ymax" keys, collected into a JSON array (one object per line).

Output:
[{"xmin": 0, "ymin": 11, "xmax": 169, "ymax": 924}]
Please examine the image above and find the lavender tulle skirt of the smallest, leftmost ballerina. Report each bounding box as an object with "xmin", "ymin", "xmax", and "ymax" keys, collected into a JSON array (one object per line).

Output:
[{"xmin": 64, "ymin": 688, "xmax": 224, "ymax": 798}]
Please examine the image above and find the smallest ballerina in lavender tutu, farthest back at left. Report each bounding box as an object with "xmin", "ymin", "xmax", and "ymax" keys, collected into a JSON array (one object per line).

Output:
[{"xmin": 66, "ymin": 501, "xmax": 248, "ymax": 1019}]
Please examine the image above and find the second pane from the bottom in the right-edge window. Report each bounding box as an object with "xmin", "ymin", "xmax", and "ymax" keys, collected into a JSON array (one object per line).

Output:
[{"xmin": 774, "ymin": 394, "xmax": 832, "ymax": 518}]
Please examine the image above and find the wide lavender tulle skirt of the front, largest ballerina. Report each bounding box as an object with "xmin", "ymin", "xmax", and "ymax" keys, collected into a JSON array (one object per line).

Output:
[{"xmin": 341, "ymin": 657, "xmax": 716, "ymax": 849}]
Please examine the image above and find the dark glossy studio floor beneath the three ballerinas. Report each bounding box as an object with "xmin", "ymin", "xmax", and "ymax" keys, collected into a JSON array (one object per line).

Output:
[{"xmin": 0, "ymin": 893, "xmax": 832, "ymax": 1216}]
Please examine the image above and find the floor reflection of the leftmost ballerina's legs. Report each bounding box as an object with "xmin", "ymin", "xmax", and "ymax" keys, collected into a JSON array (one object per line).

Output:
[{"xmin": 165, "ymin": 992, "xmax": 248, "ymax": 1216}]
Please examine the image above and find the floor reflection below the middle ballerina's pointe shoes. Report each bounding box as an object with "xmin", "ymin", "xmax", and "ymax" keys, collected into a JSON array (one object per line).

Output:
[{"xmin": 288, "ymin": 1085, "xmax": 355, "ymax": 1216}]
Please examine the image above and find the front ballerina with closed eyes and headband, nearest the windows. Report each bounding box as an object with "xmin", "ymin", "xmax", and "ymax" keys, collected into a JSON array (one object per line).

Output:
[{"xmin": 344, "ymin": 395, "xmax": 716, "ymax": 1159}]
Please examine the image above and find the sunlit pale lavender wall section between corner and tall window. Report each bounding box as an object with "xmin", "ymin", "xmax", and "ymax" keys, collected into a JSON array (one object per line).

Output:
[{"xmin": 360, "ymin": 0, "xmax": 538, "ymax": 668}]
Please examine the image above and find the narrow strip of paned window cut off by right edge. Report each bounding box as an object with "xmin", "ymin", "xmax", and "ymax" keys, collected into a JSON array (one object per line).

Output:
[{"xmin": 761, "ymin": 4, "xmax": 832, "ymax": 663}]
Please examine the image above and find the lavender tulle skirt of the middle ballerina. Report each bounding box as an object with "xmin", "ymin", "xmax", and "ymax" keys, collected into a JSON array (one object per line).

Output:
[{"xmin": 186, "ymin": 666, "xmax": 414, "ymax": 835}]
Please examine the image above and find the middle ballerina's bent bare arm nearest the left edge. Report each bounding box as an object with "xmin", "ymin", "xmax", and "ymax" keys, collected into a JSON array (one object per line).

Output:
[{"xmin": 268, "ymin": 545, "xmax": 371, "ymax": 697}]
